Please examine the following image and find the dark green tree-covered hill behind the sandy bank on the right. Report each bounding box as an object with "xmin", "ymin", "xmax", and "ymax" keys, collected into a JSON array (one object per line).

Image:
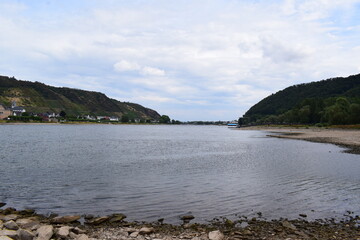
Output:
[{"xmin": 244, "ymin": 74, "xmax": 360, "ymax": 124}]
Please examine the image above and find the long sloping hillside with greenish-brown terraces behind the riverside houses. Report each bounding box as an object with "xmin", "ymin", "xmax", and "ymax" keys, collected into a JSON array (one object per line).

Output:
[{"xmin": 0, "ymin": 76, "xmax": 160, "ymax": 120}]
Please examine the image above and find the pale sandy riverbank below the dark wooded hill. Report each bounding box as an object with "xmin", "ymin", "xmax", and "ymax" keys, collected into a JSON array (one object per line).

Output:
[{"xmin": 238, "ymin": 126, "xmax": 360, "ymax": 154}]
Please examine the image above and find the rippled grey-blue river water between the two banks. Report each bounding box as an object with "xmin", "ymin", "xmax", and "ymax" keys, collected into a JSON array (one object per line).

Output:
[{"xmin": 0, "ymin": 125, "xmax": 360, "ymax": 223}]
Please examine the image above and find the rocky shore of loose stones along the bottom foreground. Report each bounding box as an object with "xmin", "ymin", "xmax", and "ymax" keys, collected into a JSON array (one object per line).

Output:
[{"xmin": 0, "ymin": 203, "xmax": 360, "ymax": 240}]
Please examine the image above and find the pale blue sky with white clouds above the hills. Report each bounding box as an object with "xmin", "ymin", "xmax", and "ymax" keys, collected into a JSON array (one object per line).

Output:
[{"xmin": 0, "ymin": 0, "xmax": 360, "ymax": 121}]
